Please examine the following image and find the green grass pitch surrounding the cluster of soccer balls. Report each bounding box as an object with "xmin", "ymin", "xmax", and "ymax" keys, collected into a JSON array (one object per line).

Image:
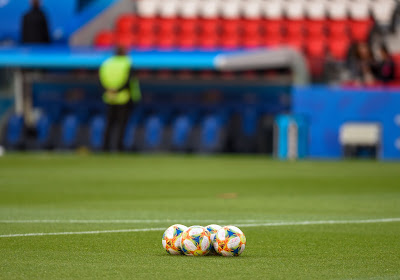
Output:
[{"xmin": 0, "ymin": 154, "xmax": 400, "ymax": 279}]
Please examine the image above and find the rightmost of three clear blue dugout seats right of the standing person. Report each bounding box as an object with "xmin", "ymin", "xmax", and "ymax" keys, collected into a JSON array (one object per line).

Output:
[{"xmin": 198, "ymin": 115, "xmax": 223, "ymax": 152}]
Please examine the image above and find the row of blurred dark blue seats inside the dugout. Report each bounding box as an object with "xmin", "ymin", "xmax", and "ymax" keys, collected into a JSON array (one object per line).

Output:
[{"xmin": 5, "ymin": 108, "xmax": 268, "ymax": 153}]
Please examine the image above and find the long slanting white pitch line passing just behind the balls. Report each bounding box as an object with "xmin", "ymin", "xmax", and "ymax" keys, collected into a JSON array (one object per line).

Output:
[{"xmin": 0, "ymin": 218, "xmax": 400, "ymax": 238}]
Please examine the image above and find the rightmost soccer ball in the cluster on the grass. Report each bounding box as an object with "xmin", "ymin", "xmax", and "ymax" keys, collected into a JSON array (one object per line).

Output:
[{"xmin": 213, "ymin": 226, "xmax": 246, "ymax": 257}]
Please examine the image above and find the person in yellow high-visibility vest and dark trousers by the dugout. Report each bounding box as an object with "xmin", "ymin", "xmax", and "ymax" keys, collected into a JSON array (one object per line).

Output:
[{"xmin": 99, "ymin": 47, "xmax": 141, "ymax": 151}]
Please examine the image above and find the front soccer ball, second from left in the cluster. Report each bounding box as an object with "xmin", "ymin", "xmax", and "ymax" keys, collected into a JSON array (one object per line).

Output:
[{"xmin": 181, "ymin": 226, "xmax": 212, "ymax": 256}]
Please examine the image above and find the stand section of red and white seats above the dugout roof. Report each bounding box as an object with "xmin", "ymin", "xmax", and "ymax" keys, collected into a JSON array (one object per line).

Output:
[{"xmin": 94, "ymin": 0, "xmax": 396, "ymax": 76}]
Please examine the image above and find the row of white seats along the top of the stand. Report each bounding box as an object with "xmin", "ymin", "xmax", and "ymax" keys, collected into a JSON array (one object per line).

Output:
[{"xmin": 136, "ymin": 0, "xmax": 397, "ymax": 22}]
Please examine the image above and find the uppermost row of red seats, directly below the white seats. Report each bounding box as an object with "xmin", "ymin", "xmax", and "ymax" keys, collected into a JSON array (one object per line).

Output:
[{"xmin": 111, "ymin": 14, "xmax": 373, "ymax": 37}]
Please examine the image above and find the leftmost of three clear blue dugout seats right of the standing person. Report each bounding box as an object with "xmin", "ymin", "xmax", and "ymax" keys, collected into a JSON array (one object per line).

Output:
[{"xmin": 143, "ymin": 116, "xmax": 164, "ymax": 150}]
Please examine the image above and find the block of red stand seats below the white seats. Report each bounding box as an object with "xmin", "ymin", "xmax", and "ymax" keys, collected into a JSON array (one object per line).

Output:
[{"xmin": 95, "ymin": 14, "xmax": 372, "ymax": 59}]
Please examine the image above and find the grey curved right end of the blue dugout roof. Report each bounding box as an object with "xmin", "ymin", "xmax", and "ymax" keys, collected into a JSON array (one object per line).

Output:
[{"xmin": 215, "ymin": 48, "xmax": 310, "ymax": 85}]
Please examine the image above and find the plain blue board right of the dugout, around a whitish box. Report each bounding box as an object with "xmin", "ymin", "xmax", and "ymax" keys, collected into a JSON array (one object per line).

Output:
[{"xmin": 292, "ymin": 86, "xmax": 400, "ymax": 160}]
